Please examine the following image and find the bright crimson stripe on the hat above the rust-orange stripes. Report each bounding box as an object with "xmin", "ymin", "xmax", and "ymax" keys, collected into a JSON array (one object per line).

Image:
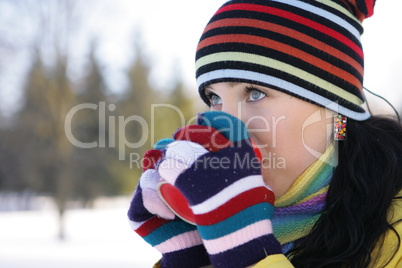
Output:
[{"xmin": 216, "ymin": 4, "xmax": 364, "ymax": 58}]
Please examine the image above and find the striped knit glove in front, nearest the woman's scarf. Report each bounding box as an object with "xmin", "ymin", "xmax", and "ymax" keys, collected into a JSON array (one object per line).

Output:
[{"xmin": 158, "ymin": 112, "xmax": 282, "ymax": 267}]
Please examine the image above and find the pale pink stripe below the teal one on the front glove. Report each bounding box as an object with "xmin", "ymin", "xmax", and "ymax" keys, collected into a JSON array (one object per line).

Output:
[{"xmin": 204, "ymin": 220, "xmax": 272, "ymax": 255}]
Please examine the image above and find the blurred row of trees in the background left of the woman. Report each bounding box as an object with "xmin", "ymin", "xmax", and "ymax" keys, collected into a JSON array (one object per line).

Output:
[{"xmin": 0, "ymin": 0, "xmax": 201, "ymax": 238}]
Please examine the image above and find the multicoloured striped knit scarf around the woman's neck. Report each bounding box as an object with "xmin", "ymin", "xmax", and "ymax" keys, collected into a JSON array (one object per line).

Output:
[{"xmin": 272, "ymin": 142, "xmax": 335, "ymax": 254}]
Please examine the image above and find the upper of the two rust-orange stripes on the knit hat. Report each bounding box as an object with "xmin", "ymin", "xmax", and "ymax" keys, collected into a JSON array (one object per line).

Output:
[{"xmin": 197, "ymin": 18, "xmax": 364, "ymax": 77}]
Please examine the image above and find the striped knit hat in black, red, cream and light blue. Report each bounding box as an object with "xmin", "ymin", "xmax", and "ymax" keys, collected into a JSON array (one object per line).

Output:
[{"xmin": 196, "ymin": 0, "xmax": 375, "ymax": 120}]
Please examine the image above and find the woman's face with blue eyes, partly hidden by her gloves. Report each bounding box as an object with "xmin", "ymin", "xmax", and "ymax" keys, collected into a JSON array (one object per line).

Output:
[{"xmin": 205, "ymin": 82, "xmax": 333, "ymax": 198}]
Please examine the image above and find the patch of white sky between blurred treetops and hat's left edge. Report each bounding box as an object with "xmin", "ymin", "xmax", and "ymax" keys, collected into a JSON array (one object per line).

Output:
[{"xmin": 90, "ymin": 0, "xmax": 226, "ymax": 93}]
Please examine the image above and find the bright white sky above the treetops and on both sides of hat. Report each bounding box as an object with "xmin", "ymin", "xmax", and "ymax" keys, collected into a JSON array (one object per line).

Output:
[{"xmin": 0, "ymin": 0, "xmax": 402, "ymax": 116}]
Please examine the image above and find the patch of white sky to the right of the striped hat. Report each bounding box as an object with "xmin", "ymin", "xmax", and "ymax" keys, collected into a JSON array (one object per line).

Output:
[{"xmin": 362, "ymin": 0, "xmax": 402, "ymax": 113}]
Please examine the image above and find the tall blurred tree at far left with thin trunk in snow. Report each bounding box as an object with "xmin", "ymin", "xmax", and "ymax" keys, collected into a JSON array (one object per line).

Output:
[{"xmin": 1, "ymin": 0, "xmax": 77, "ymax": 238}]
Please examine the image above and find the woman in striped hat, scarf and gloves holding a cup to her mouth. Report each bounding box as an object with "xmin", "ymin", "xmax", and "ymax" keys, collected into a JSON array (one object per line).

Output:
[{"xmin": 128, "ymin": 0, "xmax": 402, "ymax": 267}]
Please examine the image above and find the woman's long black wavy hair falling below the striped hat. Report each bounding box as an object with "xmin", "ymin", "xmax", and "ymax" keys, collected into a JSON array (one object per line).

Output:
[{"xmin": 290, "ymin": 116, "xmax": 402, "ymax": 268}]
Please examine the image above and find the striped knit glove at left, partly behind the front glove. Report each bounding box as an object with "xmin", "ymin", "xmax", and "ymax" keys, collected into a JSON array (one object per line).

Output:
[{"xmin": 128, "ymin": 140, "xmax": 210, "ymax": 267}]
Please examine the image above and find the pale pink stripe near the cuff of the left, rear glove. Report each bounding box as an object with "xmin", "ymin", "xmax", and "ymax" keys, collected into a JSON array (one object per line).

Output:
[{"xmin": 155, "ymin": 230, "xmax": 202, "ymax": 253}]
